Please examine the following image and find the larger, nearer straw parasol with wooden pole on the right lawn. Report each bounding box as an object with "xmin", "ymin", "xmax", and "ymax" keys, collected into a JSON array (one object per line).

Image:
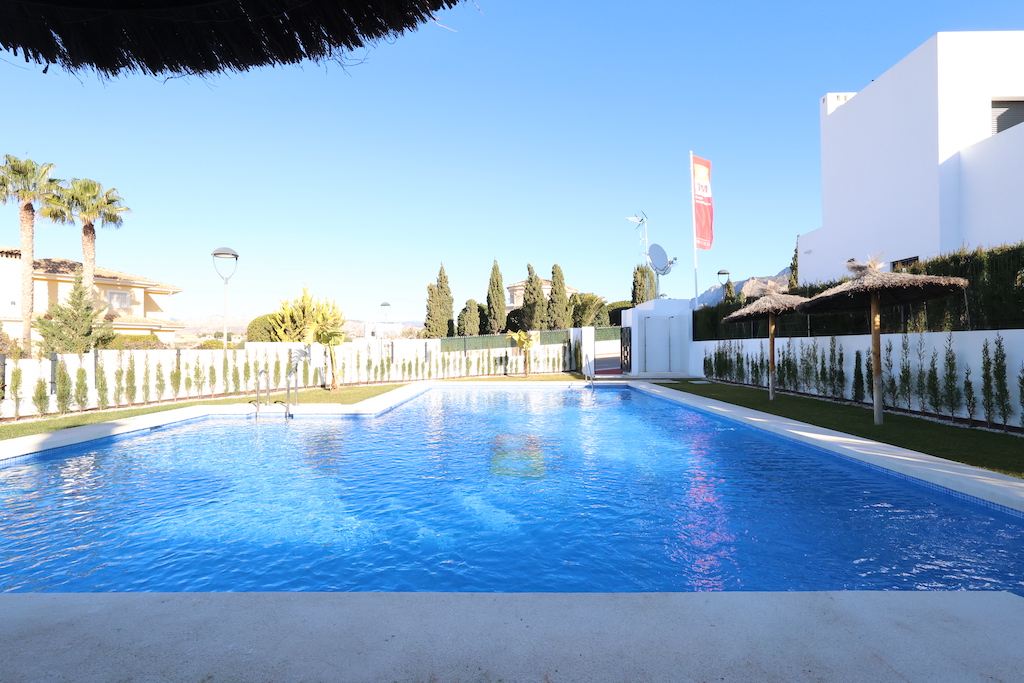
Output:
[{"xmin": 798, "ymin": 259, "xmax": 968, "ymax": 425}]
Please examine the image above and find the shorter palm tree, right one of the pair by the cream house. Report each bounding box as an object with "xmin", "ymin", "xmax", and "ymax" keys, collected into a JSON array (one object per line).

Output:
[{"xmin": 48, "ymin": 178, "xmax": 131, "ymax": 300}]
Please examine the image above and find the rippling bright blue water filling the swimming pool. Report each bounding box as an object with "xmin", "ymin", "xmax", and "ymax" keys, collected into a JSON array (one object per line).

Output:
[{"xmin": 0, "ymin": 387, "xmax": 1024, "ymax": 592}]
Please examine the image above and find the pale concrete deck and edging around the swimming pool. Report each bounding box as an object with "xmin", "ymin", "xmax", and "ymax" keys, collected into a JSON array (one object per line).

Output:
[{"xmin": 0, "ymin": 382, "xmax": 1024, "ymax": 683}]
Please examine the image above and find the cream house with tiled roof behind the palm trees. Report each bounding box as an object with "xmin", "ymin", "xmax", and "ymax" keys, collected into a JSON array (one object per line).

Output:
[{"xmin": 0, "ymin": 247, "xmax": 184, "ymax": 342}]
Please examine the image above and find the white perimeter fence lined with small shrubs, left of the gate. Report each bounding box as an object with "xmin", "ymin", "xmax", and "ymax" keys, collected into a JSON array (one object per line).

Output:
[{"xmin": 0, "ymin": 329, "xmax": 594, "ymax": 418}]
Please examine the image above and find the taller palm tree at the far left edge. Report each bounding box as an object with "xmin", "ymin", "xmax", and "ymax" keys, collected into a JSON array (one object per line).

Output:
[{"xmin": 0, "ymin": 155, "xmax": 60, "ymax": 354}]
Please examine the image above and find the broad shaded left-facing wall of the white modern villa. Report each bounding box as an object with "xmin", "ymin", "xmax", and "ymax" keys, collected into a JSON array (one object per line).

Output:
[{"xmin": 800, "ymin": 38, "xmax": 939, "ymax": 282}]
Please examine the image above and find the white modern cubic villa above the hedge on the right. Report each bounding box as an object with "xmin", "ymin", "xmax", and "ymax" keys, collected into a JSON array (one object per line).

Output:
[{"xmin": 799, "ymin": 31, "xmax": 1024, "ymax": 283}]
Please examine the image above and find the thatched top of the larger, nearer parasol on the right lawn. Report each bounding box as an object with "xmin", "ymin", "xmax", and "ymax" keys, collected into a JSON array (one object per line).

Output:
[{"xmin": 798, "ymin": 260, "xmax": 968, "ymax": 313}]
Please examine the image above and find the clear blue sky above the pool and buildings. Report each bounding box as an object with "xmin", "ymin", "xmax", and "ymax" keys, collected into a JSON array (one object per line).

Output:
[{"xmin": 0, "ymin": 0, "xmax": 1024, "ymax": 321}]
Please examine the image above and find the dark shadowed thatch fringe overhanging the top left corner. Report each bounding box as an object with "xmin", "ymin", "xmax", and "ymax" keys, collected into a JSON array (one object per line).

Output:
[{"xmin": 0, "ymin": 0, "xmax": 458, "ymax": 76}]
